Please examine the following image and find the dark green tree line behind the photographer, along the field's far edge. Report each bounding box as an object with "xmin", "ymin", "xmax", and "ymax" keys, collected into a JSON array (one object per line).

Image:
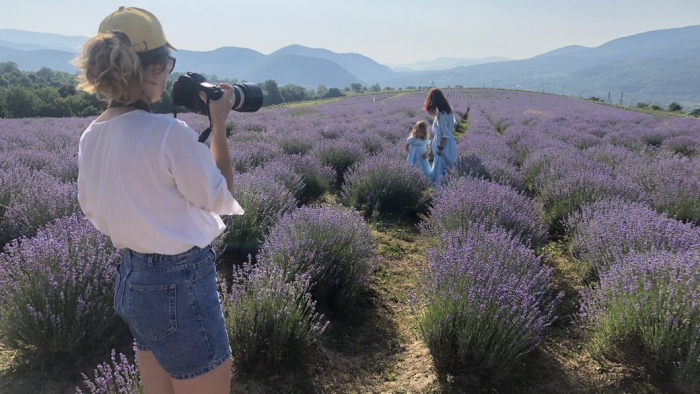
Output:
[{"xmin": 0, "ymin": 62, "xmax": 404, "ymax": 118}]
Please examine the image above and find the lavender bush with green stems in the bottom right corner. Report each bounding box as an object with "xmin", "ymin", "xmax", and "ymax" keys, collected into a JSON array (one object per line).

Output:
[{"xmin": 581, "ymin": 250, "xmax": 700, "ymax": 394}]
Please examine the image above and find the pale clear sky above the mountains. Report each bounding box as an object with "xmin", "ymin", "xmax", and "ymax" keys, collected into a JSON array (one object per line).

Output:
[{"xmin": 0, "ymin": 0, "xmax": 700, "ymax": 65}]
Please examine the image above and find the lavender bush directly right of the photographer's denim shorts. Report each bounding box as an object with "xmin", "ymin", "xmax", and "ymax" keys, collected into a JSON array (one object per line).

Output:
[{"xmin": 221, "ymin": 264, "xmax": 328, "ymax": 370}]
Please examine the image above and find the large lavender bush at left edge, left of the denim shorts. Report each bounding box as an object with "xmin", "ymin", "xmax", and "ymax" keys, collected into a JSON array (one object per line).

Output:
[{"xmin": 0, "ymin": 214, "xmax": 121, "ymax": 356}]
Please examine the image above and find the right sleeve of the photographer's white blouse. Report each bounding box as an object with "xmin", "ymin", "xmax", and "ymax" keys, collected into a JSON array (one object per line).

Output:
[{"xmin": 164, "ymin": 120, "xmax": 244, "ymax": 215}]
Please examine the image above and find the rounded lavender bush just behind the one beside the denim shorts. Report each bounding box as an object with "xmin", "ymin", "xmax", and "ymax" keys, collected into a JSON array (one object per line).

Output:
[{"xmin": 258, "ymin": 207, "xmax": 374, "ymax": 310}]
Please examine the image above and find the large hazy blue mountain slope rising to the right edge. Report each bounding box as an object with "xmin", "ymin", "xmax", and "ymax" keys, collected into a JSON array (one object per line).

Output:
[{"xmin": 381, "ymin": 25, "xmax": 700, "ymax": 104}]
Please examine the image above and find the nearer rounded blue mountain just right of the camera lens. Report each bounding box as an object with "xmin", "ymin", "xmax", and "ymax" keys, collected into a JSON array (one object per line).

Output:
[{"xmin": 244, "ymin": 54, "xmax": 360, "ymax": 88}]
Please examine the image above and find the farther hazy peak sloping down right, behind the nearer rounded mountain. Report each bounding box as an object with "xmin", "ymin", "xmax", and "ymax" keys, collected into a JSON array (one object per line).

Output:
[{"xmin": 270, "ymin": 45, "xmax": 396, "ymax": 84}]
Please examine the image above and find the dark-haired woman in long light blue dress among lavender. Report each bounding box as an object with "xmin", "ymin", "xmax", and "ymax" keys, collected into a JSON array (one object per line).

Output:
[{"xmin": 423, "ymin": 88, "xmax": 457, "ymax": 185}]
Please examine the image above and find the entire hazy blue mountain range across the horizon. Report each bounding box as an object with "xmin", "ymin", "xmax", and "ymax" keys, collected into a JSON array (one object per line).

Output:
[{"xmin": 0, "ymin": 25, "xmax": 700, "ymax": 106}]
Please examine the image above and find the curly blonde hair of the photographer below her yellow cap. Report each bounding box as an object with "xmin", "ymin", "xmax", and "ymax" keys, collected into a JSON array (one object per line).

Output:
[{"xmin": 73, "ymin": 31, "xmax": 170, "ymax": 110}]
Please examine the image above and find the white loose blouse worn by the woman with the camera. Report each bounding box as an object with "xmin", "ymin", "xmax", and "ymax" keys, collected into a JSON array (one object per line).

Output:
[{"xmin": 78, "ymin": 110, "xmax": 244, "ymax": 255}]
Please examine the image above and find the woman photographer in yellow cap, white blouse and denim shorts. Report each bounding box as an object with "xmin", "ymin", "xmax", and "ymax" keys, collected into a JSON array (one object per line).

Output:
[{"xmin": 75, "ymin": 7, "xmax": 243, "ymax": 394}]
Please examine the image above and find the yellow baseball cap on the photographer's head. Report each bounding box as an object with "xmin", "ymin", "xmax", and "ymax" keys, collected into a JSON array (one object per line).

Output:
[{"xmin": 98, "ymin": 7, "xmax": 175, "ymax": 52}]
